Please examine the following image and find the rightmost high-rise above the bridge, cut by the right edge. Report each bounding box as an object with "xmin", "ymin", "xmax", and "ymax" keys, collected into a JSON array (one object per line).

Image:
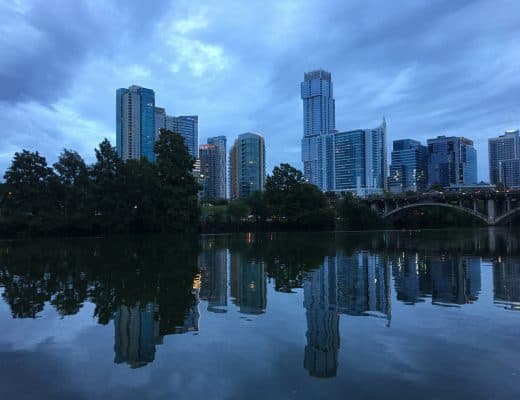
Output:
[{"xmin": 488, "ymin": 130, "xmax": 520, "ymax": 187}]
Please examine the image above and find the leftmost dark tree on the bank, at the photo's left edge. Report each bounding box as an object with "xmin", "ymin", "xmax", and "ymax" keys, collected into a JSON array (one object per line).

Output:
[{"xmin": 3, "ymin": 150, "xmax": 58, "ymax": 231}]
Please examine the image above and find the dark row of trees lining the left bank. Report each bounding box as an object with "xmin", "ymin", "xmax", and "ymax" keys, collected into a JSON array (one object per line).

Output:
[{"xmin": 0, "ymin": 130, "xmax": 200, "ymax": 235}]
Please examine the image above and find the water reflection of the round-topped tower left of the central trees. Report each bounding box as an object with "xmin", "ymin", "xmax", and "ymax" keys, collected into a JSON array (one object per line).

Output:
[{"xmin": 230, "ymin": 253, "xmax": 267, "ymax": 314}]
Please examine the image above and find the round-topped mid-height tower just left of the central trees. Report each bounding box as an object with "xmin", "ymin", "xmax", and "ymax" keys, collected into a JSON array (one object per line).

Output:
[{"xmin": 229, "ymin": 133, "xmax": 265, "ymax": 200}]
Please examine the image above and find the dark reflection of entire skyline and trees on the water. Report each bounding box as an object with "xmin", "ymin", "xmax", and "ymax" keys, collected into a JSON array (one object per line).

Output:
[{"xmin": 0, "ymin": 230, "xmax": 520, "ymax": 378}]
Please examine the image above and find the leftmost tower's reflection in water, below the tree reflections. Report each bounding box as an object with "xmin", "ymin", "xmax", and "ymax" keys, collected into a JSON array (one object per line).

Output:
[{"xmin": 114, "ymin": 303, "xmax": 162, "ymax": 368}]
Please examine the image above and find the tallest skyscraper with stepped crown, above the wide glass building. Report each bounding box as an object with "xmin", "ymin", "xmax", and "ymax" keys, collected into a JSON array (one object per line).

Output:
[{"xmin": 301, "ymin": 70, "xmax": 336, "ymax": 188}]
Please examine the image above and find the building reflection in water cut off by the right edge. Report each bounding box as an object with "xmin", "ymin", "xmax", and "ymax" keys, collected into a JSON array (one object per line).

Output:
[{"xmin": 493, "ymin": 257, "xmax": 520, "ymax": 311}]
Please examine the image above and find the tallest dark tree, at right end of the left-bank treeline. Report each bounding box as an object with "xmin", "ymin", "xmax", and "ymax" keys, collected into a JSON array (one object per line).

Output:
[{"xmin": 154, "ymin": 129, "xmax": 200, "ymax": 231}]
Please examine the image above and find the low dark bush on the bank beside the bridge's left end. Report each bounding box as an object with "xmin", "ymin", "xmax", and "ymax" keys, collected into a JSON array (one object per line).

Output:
[{"xmin": 337, "ymin": 193, "xmax": 385, "ymax": 230}]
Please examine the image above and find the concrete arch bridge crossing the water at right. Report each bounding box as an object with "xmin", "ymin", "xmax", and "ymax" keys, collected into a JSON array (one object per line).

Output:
[{"xmin": 366, "ymin": 191, "xmax": 520, "ymax": 226}]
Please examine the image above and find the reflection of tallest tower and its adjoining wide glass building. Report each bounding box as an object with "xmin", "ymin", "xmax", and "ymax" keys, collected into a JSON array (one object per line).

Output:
[{"xmin": 303, "ymin": 252, "xmax": 391, "ymax": 378}]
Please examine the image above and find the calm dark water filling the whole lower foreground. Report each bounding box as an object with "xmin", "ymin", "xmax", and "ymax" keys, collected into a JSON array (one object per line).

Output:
[{"xmin": 0, "ymin": 229, "xmax": 520, "ymax": 400}]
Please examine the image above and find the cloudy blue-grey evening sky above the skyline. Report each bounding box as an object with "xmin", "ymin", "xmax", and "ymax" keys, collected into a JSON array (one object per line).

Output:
[{"xmin": 0, "ymin": 0, "xmax": 520, "ymax": 180}]
